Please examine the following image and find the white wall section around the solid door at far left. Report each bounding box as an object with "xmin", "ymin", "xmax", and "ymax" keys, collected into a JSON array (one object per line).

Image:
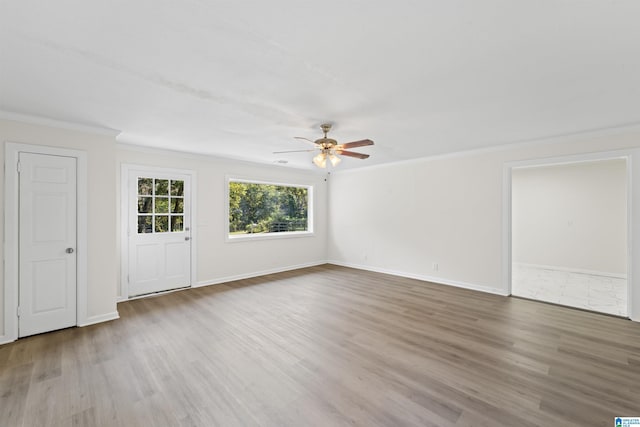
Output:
[{"xmin": 0, "ymin": 119, "xmax": 117, "ymax": 341}]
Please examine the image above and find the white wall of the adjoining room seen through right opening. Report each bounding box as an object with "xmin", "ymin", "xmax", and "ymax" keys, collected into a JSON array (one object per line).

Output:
[{"xmin": 512, "ymin": 160, "xmax": 627, "ymax": 275}]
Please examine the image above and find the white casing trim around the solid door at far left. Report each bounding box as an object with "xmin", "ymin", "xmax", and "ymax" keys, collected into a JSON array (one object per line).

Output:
[{"xmin": 0, "ymin": 142, "xmax": 89, "ymax": 343}]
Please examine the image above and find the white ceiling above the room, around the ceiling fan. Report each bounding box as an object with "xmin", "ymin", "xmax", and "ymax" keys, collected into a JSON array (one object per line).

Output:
[{"xmin": 0, "ymin": 0, "xmax": 640, "ymax": 169}]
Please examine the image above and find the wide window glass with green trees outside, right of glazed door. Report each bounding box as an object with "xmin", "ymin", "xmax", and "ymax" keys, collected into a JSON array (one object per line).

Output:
[{"xmin": 229, "ymin": 179, "xmax": 313, "ymax": 238}]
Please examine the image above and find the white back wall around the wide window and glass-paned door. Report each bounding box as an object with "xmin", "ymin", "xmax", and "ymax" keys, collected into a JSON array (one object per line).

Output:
[{"xmin": 116, "ymin": 145, "xmax": 327, "ymax": 296}]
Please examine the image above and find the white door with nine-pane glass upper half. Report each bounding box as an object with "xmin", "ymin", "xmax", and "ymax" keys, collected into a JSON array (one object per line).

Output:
[{"xmin": 127, "ymin": 170, "xmax": 191, "ymax": 296}]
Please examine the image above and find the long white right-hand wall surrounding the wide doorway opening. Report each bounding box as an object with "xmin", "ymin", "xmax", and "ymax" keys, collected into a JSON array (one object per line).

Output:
[{"xmin": 328, "ymin": 132, "xmax": 640, "ymax": 318}]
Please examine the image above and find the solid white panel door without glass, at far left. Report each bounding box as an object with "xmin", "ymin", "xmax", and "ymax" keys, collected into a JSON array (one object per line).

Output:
[{"xmin": 18, "ymin": 153, "xmax": 77, "ymax": 337}]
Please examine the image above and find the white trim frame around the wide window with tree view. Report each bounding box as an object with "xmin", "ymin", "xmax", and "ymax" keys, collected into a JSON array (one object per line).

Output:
[{"xmin": 224, "ymin": 175, "xmax": 315, "ymax": 243}]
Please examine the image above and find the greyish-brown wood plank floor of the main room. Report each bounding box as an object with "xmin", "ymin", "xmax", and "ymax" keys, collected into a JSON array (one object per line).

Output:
[{"xmin": 0, "ymin": 265, "xmax": 640, "ymax": 427}]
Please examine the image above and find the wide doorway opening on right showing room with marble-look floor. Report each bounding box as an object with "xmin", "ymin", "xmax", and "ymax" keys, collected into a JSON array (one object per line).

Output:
[{"xmin": 510, "ymin": 157, "xmax": 629, "ymax": 317}]
